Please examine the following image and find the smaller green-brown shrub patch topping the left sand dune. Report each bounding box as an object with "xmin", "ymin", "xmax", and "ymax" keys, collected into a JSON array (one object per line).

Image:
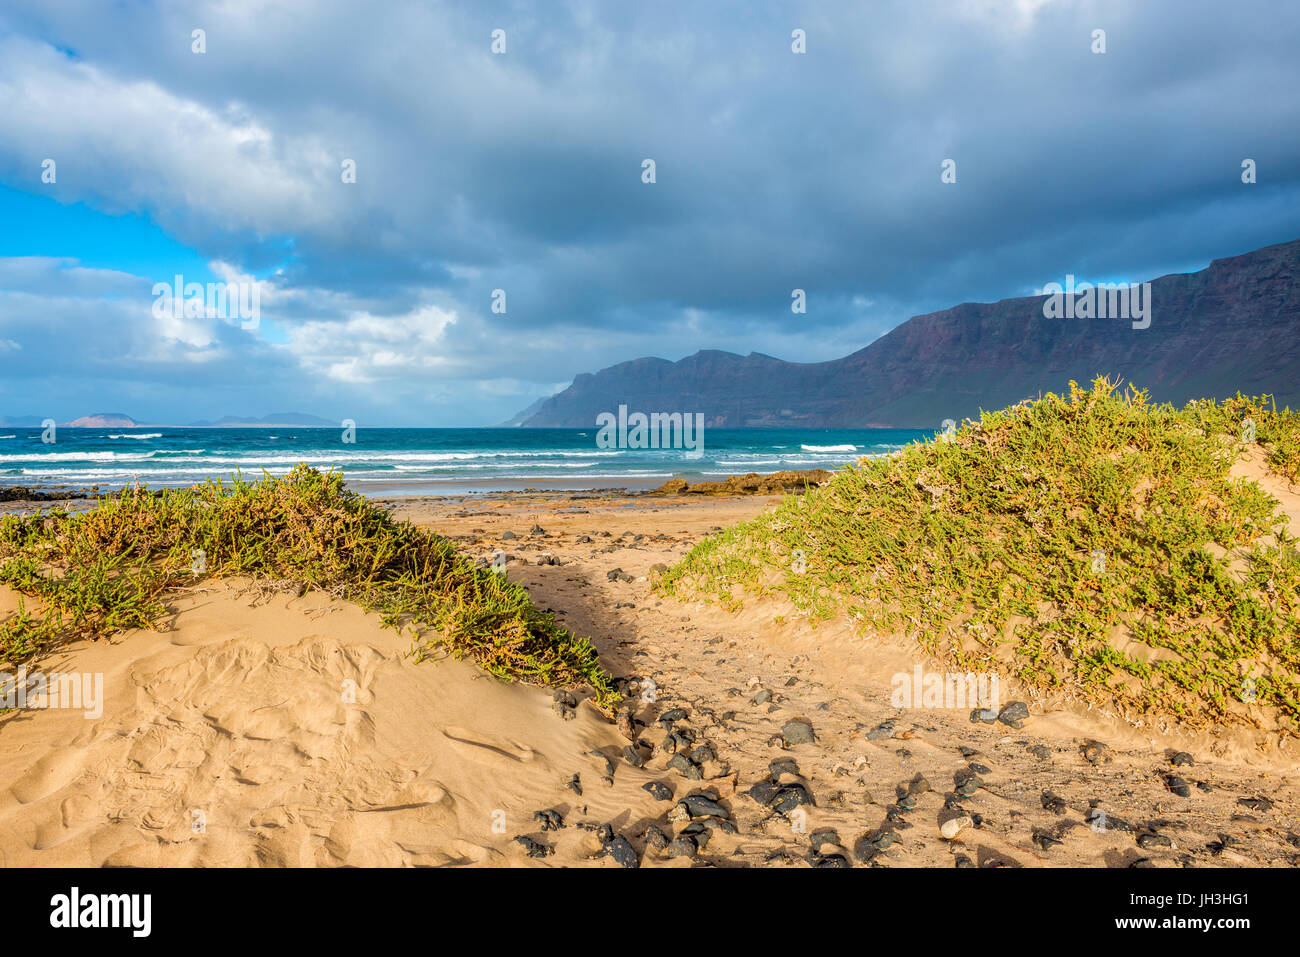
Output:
[{"xmin": 0, "ymin": 465, "xmax": 618, "ymax": 707}]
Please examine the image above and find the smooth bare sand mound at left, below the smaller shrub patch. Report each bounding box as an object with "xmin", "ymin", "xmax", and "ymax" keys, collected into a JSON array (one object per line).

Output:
[{"xmin": 0, "ymin": 574, "xmax": 654, "ymax": 866}]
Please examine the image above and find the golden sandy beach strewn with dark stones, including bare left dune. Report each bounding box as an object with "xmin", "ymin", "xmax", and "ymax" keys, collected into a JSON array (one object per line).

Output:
[{"xmin": 0, "ymin": 462, "xmax": 1300, "ymax": 867}]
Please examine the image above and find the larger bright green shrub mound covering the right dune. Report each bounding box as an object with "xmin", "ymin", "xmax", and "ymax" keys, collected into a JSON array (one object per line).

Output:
[{"xmin": 657, "ymin": 380, "xmax": 1300, "ymax": 733}]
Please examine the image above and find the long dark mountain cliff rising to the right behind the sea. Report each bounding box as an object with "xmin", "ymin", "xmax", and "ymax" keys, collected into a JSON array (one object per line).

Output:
[{"xmin": 516, "ymin": 239, "xmax": 1300, "ymax": 428}]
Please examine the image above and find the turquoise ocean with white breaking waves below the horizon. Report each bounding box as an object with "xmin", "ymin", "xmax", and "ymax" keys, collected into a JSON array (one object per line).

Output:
[{"xmin": 0, "ymin": 426, "xmax": 933, "ymax": 497}]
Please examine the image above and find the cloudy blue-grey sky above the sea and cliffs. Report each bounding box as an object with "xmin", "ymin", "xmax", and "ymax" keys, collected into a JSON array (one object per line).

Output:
[{"xmin": 0, "ymin": 0, "xmax": 1300, "ymax": 426}]
